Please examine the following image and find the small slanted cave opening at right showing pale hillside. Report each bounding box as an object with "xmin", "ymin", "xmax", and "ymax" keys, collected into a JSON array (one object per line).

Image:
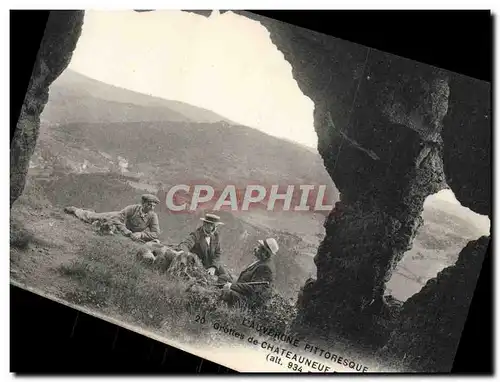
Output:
[{"xmin": 385, "ymin": 189, "xmax": 490, "ymax": 301}]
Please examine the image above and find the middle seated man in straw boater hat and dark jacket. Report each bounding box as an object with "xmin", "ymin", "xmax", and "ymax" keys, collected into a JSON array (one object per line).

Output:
[{"xmin": 178, "ymin": 214, "xmax": 231, "ymax": 282}]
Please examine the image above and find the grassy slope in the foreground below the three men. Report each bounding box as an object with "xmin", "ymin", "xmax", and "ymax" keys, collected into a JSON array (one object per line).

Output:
[{"xmin": 10, "ymin": 179, "xmax": 394, "ymax": 367}]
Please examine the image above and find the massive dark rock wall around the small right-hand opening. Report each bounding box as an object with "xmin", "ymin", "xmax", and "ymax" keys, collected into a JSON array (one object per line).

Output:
[{"xmin": 244, "ymin": 16, "xmax": 491, "ymax": 371}]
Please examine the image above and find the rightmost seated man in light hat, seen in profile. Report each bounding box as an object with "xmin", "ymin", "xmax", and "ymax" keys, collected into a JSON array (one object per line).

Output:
[{"xmin": 222, "ymin": 238, "xmax": 279, "ymax": 307}]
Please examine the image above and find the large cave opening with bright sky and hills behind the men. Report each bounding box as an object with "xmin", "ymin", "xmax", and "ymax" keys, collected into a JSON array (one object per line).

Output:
[{"xmin": 38, "ymin": 11, "xmax": 338, "ymax": 298}]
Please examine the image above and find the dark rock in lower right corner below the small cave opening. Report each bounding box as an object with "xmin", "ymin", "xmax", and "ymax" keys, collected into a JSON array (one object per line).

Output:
[{"xmin": 379, "ymin": 236, "xmax": 490, "ymax": 373}]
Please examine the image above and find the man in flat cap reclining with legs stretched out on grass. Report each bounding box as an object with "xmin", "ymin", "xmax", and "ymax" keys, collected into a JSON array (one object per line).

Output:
[{"xmin": 64, "ymin": 194, "xmax": 160, "ymax": 242}]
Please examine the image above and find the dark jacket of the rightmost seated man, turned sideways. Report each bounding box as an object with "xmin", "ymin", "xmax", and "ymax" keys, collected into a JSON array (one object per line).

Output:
[{"xmin": 231, "ymin": 259, "xmax": 276, "ymax": 301}]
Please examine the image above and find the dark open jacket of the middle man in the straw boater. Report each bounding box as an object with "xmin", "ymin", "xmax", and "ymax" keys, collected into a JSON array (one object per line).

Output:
[{"xmin": 179, "ymin": 227, "xmax": 221, "ymax": 268}]
